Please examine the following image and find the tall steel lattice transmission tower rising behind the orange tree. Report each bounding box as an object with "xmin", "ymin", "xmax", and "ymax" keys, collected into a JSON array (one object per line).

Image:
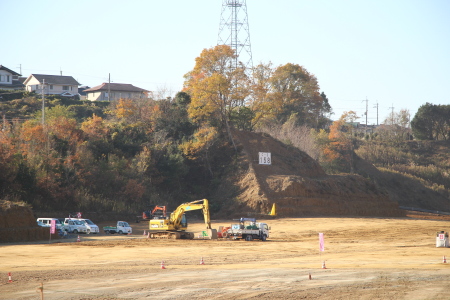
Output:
[{"xmin": 217, "ymin": 0, "xmax": 253, "ymax": 70}]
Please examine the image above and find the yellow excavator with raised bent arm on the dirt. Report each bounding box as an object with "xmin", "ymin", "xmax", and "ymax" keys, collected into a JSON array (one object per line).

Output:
[{"xmin": 148, "ymin": 199, "xmax": 217, "ymax": 239}]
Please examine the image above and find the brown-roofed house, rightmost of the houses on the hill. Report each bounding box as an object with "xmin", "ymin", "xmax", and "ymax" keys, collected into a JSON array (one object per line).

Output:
[{"xmin": 84, "ymin": 83, "xmax": 149, "ymax": 101}]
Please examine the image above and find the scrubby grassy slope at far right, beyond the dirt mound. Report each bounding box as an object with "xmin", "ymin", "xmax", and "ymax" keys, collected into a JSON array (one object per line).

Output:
[{"xmin": 356, "ymin": 141, "xmax": 450, "ymax": 212}]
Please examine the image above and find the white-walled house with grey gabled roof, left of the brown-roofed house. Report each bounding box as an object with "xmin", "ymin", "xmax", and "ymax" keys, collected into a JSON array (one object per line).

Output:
[{"xmin": 24, "ymin": 74, "xmax": 80, "ymax": 97}]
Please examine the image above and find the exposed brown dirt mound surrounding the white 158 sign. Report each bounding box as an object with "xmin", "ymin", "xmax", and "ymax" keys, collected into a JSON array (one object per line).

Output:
[{"xmin": 216, "ymin": 131, "xmax": 404, "ymax": 217}]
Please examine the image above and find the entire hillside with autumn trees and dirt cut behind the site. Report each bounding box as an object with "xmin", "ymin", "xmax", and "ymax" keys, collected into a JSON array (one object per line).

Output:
[{"xmin": 0, "ymin": 45, "xmax": 450, "ymax": 216}]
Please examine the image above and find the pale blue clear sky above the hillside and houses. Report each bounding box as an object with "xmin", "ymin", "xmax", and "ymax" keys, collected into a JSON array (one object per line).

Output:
[{"xmin": 0, "ymin": 0, "xmax": 450, "ymax": 124}]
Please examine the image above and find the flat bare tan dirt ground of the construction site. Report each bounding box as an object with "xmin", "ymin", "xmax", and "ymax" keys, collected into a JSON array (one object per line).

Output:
[{"xmin": 0, "ymin": 213, "xmax": 450, "ymax": 300}]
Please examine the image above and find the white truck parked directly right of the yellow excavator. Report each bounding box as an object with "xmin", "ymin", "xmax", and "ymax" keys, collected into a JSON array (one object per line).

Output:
[{"xmin": 222, "ymin": 218, "xmax": 270, "ymax": 241}]
